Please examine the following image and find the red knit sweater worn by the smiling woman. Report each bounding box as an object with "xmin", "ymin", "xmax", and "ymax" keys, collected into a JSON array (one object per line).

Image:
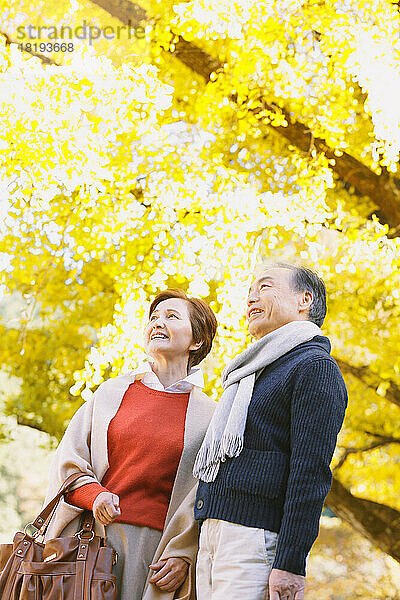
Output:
[{"xmin": 66, "ymin": 381, "xmax": 189, "ymax": 531}]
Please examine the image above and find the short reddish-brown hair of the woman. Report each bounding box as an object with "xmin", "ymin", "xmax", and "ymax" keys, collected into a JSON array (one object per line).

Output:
[{"xmin": 149, "ymin": 289, "xmax": 218, "ymax": 370}]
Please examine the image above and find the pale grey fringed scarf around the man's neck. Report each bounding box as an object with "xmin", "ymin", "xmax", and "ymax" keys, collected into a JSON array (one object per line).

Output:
[{"xmin": 193, "ymin": 321, "xmax": 323, "ymax": 482}]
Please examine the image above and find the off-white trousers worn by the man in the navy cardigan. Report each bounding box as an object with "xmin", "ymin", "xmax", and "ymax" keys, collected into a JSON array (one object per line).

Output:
[{"xmin": 196, "ymin": 519, "xmax": 278, "ymax": 600}]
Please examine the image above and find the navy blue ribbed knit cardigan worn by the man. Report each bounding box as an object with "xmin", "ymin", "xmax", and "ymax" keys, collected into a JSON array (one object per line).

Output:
[{"xmin": 195, "ymin": 336, "xmax": 347, "ymax": 575}]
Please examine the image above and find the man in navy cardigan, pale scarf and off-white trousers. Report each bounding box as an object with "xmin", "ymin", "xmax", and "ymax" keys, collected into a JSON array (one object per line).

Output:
[{"xmin": 194, "ymin": 264, "xmax": 347, "ymax": 600}]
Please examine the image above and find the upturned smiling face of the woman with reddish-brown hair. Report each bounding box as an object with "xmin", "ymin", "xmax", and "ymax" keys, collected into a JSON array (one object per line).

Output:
[{"xmin": 144, "ymin": 298, "xmax": 201, "ymax": 360}]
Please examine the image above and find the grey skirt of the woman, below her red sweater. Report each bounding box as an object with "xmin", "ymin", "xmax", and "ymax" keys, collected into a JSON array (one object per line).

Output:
[{"xmin": 106, "ymin": 523, "xmax": 162, "ymax": 600}]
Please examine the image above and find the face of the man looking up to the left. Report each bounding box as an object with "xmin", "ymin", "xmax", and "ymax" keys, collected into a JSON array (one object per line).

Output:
[{"xmin": 246, "ymin": 268, "xmax": 312, "ymax": 340}]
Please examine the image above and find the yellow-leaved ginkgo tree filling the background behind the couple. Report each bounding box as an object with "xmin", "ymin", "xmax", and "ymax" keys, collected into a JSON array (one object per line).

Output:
[{"xmin": 0, "ymin": 0, "xmax": 400, "ymax": 560}]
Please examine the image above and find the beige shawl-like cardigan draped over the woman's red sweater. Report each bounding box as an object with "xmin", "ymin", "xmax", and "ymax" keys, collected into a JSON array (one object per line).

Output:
[{"xmin": 45, "ymin": 371, "xmax": 215, "ymax": 600}]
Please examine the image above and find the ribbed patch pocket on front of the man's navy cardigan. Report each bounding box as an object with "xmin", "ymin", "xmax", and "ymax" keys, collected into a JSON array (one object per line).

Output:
[{"xmin": 225, "ymin": 448, "xmax": 289, "ymax": 498}]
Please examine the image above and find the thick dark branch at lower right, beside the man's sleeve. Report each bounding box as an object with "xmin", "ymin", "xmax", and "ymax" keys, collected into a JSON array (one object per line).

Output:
[{"xmin": 326, "ymin": 478, "xmax": 400, "ymax": 562}]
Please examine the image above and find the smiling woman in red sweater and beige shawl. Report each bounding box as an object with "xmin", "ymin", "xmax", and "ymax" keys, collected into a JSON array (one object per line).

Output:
[{"xmin": 46, "ymin": 290, "xmax": 217, "ymax": 600}]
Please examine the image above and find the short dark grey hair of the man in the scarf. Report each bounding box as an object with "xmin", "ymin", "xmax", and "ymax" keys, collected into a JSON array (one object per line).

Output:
[{"xmin": 268, "ymin": 263, "xmax": 326, "ymax": 327}]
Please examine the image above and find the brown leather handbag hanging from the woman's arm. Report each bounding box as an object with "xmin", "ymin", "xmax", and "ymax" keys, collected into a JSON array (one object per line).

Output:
[{"xmin": 0, "ymin": 473, "xmax": 117, "ymax": 600}]
